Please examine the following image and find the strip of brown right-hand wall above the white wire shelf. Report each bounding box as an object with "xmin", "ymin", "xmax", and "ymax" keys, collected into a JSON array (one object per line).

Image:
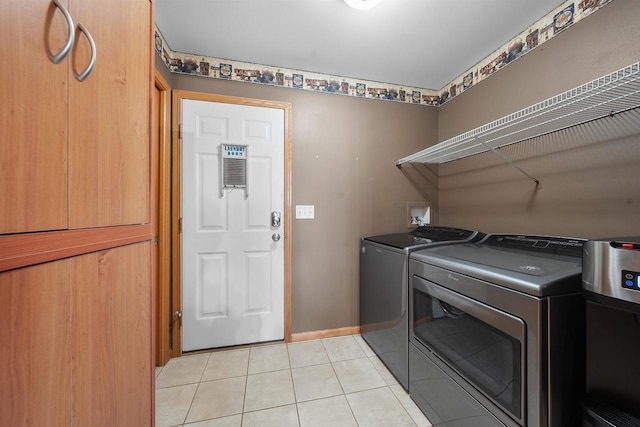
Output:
[{"xmin": 438, "ymin": 0, "xmax": 640, "ymax": 141}]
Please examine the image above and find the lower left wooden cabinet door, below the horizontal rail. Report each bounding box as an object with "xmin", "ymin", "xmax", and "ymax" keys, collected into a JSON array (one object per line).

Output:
[{"xmin": 0, "ymin": 260, "xmax": 71, "ymax": 426}]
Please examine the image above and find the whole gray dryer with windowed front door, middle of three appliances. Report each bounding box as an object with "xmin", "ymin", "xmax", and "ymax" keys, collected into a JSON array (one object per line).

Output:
[{"xmin": 409, "ymin": 234, "xmax": 585, "ymax": 427}]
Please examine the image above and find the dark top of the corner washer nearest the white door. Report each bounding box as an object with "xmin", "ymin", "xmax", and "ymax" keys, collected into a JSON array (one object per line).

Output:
[{"xmin": 363, "ymin": 226, "xmax": 484, "ymax": 249}]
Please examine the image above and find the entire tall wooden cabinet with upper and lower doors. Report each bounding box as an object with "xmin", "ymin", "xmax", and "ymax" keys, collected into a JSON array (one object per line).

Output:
[{"xmin": 0, "ymin": 0, "xmax": 155, "ymax": 427}]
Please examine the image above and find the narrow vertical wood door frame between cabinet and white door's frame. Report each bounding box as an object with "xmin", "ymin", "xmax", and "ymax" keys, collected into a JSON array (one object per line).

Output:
[{"xmin": 151, "ymin": 70, "xmax": 175, "ymax": 366}]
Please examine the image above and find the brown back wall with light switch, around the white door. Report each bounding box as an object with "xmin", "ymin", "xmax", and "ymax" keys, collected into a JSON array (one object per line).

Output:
[{"xmin": 158, "ymin": 70, "xmax": 438, "ymax": 333}]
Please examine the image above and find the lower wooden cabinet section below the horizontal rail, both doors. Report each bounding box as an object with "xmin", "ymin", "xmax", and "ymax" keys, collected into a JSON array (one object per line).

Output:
[{"xmin": 0, "ymin": 242, "xmax": 153, "ymax": 427}]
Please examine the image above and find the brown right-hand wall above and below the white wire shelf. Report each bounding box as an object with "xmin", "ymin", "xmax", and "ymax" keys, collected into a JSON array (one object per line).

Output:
[{"xmin": 439, "ymin": 0, "xmax": 640, "ymax": 238}]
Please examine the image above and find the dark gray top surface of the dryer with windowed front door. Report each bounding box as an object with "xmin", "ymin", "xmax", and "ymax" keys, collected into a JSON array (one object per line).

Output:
[{"xmin": 411, "ymin": 234, "xmax": 585, "ymax": 297}]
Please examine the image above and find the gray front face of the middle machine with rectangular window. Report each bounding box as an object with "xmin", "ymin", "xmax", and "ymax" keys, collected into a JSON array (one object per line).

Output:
[{"xmin": 409, "ymin": 261, "xmax": 528, "ymax": 427}]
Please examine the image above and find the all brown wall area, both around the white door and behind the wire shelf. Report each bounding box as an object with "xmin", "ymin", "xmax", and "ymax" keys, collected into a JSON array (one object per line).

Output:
[{"xmin": 158, "ymin": 0, "xmax": 640, "ymax": 333}]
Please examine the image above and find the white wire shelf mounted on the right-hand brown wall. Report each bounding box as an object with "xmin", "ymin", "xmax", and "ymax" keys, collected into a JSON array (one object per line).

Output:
[{"xmin": 396, "ymin": 62, "xmax": 640, "ymax": 166}]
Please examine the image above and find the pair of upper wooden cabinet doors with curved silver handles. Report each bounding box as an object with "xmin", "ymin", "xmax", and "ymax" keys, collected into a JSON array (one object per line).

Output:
[{"xmin": 0, "ymin": 0, "xmax": 152, "ymax": 234}]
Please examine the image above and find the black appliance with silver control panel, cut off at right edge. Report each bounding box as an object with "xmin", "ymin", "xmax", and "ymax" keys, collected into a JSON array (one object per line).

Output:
[{"xmin": 582, "ymin": 236, "xmax": 640, "ymax": 427}]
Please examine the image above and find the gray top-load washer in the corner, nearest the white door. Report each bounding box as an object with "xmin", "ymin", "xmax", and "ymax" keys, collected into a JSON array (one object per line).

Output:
[{"xmin": 360, "ymin": 226, "xmax": 484, "ymax": 390}]
